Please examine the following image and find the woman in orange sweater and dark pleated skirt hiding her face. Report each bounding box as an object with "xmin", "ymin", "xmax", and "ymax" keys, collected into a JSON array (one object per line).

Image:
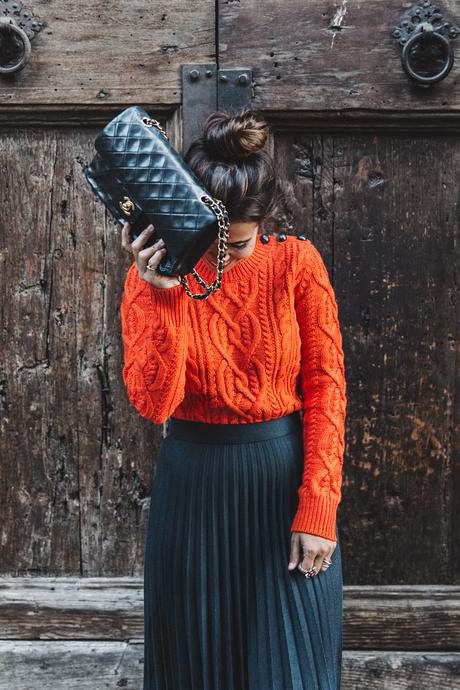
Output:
[{"xmin": 120, "ymin": 109, "xmax": 346, "ymax": 690}]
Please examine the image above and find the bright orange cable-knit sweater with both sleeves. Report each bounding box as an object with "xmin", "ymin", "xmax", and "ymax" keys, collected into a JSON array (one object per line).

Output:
[{"xmin": 120, "ymin": 236, "xmax": 346, "ymax": 541}]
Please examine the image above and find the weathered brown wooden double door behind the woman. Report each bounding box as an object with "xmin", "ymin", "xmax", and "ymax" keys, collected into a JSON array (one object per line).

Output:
[{"xmin": 0, "ymin": 0, "xmax": 460, "ymax": 690}]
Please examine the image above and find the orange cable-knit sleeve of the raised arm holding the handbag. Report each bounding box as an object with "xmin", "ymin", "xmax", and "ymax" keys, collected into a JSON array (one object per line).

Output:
[{"xmin": 120, "ymin": 263, "xmax": 189, "ymax": 424}]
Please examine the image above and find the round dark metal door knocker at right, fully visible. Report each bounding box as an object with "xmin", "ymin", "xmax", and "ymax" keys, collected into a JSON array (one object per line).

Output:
[{"xmin": 392, "ymin": 0, "xmax": 460, "ymax": 86}]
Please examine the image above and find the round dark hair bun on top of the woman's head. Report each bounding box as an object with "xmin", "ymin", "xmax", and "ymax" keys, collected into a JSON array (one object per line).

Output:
[{"xmin": 203, "ymin": 108, "xmax": 268, "ymax": 162}]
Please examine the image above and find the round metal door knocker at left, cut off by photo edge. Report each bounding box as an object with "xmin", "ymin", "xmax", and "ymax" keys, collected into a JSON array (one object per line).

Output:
[{"xmin": 0, "ymin": 0, "xmax": 42, "ymax": 76}]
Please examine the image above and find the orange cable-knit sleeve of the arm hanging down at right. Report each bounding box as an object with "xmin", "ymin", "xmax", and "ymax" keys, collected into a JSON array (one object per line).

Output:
[{"xmin": 291, "ymin": 240, "xmax": 346, "ymax": 541}]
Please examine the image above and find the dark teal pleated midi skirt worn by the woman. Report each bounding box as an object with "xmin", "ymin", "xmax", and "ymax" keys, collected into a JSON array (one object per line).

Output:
[{"xmin": 143, "ymin": 412, "xmax": 343, "ymax": 690}]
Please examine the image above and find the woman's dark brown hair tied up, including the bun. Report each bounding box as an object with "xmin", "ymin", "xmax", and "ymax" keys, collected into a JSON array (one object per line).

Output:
[{"xmin": 184, "ymin": 108, "xmax": 277, "ymax": 227}]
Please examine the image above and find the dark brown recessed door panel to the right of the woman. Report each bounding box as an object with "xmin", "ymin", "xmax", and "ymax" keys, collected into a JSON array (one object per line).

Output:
[{"xmin": 276, "ymin": 133, "xmax": 460, "ymax": 584}]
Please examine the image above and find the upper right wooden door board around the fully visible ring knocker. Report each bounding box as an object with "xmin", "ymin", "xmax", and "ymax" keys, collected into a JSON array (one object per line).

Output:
[{"xmin": 219, "ymin": 0, "xmax": 460, "ymax": 114}]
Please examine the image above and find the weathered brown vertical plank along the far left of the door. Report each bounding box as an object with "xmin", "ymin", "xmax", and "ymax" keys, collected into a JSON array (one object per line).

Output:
[{"xmin": 0, "ymin": 131, "xmax": 80, "ymax": 573}]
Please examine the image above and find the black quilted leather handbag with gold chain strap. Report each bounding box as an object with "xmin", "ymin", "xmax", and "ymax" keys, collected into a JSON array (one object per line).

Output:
[{"xmin": 84, "ymin": 105, "xmax": 230, "ymax": 299}]
